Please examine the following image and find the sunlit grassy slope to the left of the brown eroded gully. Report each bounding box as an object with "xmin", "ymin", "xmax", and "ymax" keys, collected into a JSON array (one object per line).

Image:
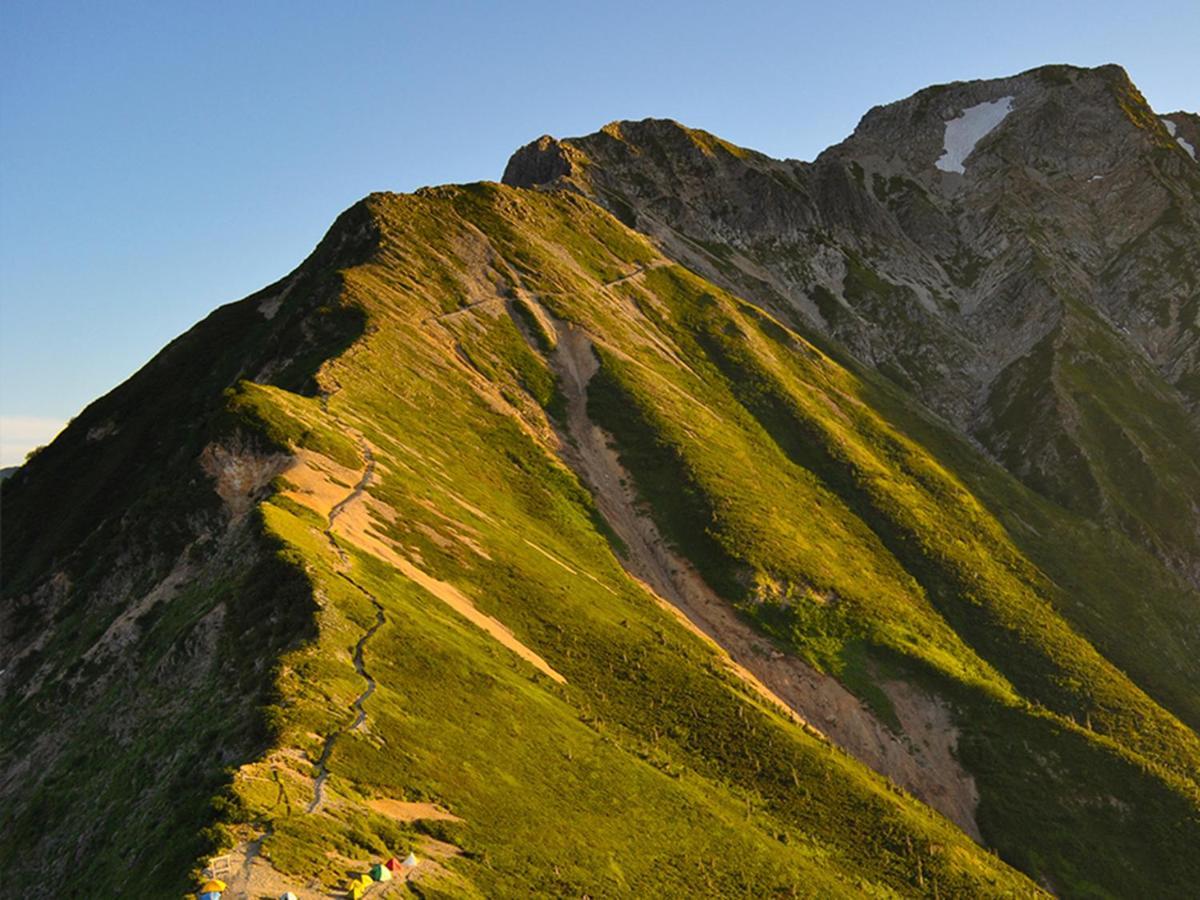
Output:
[{"xmin": 204, "ymin": 187, "xmax": 1032, "ymax": 896}]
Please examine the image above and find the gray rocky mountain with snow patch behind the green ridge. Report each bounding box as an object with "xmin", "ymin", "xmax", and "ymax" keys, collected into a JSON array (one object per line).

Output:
[{"xmin": 504, "ymin": 66, "xmax": 1200, "ymax": 583}]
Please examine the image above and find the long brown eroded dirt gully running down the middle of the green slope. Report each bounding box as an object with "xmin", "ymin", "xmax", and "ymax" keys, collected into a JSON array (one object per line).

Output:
[{"xmin": 552, "ymin": 322, "xmax": 980, "ymax": 841}]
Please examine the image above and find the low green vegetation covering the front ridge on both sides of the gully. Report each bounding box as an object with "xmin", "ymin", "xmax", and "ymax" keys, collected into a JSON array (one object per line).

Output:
[{"xmin": 0, "ymin": 180, "xmax": 1200, "ymax": 896}]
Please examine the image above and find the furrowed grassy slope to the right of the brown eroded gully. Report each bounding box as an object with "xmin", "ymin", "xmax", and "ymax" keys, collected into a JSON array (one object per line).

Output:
[{"xmin": 573, "ymin": 260, "xmax": 1198, "ymax": 893}]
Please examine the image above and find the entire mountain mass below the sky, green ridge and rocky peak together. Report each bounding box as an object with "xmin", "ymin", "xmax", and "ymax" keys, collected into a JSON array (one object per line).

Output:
[{"xmin": 0, "ymin": 66, "xmax": 1200, "ymax": 896}]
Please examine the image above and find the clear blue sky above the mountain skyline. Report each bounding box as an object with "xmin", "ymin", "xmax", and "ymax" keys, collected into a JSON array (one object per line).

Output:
[{"xmin": 0, "ymin": 0, "xmax": 1200, "ymax": 466}]
